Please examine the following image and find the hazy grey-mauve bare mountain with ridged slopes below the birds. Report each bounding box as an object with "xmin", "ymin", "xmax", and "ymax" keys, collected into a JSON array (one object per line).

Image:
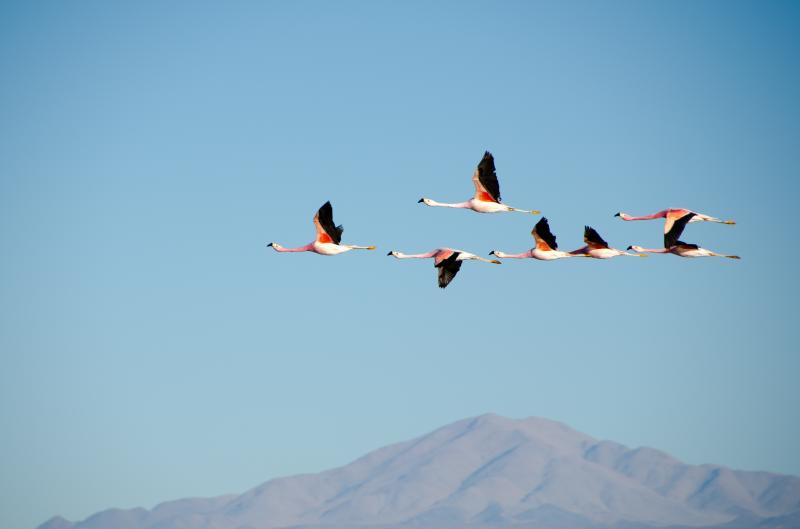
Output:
[{"xmin": 39, "ymin": 414, "xmax": 800, "ymax": 529}]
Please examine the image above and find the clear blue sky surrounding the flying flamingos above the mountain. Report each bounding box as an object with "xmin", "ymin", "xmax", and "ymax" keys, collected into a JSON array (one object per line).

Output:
[{"xmin": 0, "ymin": 1, "xmax": 800, "ymax": 529}]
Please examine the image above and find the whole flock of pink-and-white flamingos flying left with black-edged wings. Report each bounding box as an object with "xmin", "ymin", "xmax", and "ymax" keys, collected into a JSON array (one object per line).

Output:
[{"xmin": 267, "ymin": 151, "xmax": 739, "ymax": 288}]
